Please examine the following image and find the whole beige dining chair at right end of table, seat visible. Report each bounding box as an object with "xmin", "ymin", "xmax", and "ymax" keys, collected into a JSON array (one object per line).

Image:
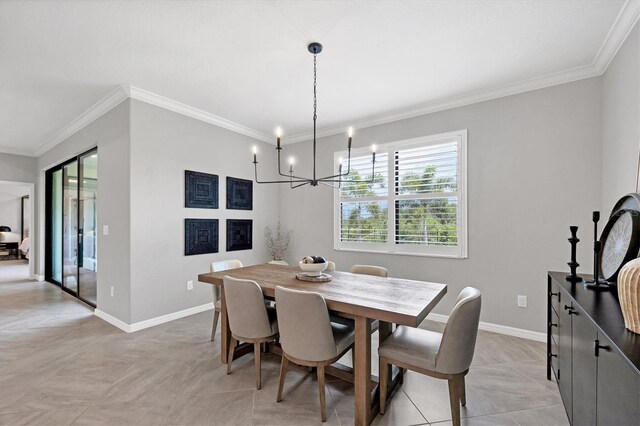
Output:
[{"xmin": 378, "ymin": 287, "xmax": 482, "ymax": 426}]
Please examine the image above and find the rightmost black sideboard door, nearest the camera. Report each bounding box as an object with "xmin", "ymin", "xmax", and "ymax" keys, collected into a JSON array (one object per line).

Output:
[{"xmin": 597, "ymin": 334, "xmax": 640, "ymax": 426}]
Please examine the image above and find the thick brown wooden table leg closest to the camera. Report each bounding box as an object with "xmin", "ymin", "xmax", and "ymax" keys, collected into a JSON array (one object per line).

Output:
[{"xmin": 354, "ymin": 317, "xmax": 372, "ymax": 426}]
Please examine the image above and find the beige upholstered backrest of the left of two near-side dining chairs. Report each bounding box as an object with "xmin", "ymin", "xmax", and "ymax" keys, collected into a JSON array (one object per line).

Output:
[{"xmin": 224, "ymin": 275, "xmax": 273, "ymax": 339}]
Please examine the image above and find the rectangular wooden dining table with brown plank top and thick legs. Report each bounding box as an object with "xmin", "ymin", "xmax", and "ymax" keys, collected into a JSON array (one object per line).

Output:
[{"xmin": 198, "ymin": 264, "xmax": 447, "ymax": 426}]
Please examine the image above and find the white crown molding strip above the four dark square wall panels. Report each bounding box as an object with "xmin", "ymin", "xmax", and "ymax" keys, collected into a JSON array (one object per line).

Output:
[{"xmin": 129, "ymin": 86, "xmax": 274, "ymax": 143}]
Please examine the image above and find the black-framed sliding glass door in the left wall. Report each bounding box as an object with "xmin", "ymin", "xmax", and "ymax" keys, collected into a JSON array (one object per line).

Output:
[{"xmin": 45, "ymin": 149, "xmax": 98, "ymax": 306}]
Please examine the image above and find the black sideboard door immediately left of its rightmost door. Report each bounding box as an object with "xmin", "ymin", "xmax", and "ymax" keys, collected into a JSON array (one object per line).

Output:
[{"xmin": 571, "ymin": 308, "xmax": 598, "ymax": 425}]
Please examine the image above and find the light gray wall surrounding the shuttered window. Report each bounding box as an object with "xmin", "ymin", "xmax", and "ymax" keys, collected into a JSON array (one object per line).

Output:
[{"xmin": 280, "ymin": 78, "xmax": 602, "ymax": 332}]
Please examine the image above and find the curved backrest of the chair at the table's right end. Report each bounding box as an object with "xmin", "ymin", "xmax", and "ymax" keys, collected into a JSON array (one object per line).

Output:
[{"xmin": 436, "ymin": 287, "xmax": 482, "ymax": 374}]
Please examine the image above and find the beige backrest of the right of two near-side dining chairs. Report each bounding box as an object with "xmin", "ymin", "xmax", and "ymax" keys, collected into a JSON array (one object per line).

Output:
[{"xmin": 276, "ymin": 286, "xmax": 338, "ymax": 362}]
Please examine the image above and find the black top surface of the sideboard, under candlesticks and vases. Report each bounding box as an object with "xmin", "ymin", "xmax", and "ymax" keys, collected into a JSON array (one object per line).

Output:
[{"xmin": 549, "ymin": 272, "xmax": 640, "ymax": 374}]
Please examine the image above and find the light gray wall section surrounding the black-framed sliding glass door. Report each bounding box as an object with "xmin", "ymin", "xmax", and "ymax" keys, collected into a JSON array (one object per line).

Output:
[{"xmin": 38, "ymin": 100, "xmax": 131, "ymax": 323}]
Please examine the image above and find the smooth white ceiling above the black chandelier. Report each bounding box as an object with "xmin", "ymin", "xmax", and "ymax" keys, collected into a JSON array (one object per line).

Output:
[{"xmin": 0, "ymin": 0, "xmax": 640, "ymax": 155}]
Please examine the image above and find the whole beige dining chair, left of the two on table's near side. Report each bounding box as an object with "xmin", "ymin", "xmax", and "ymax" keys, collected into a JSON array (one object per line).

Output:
[{"xmin": 224, "ymin": 275, "xmax": 278, "ymax": 389}]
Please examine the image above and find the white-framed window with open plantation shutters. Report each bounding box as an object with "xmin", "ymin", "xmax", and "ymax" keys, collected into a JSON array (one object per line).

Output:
[{"xmin": 334, "ymin": 130, "xmax": 467, "ymax": 258}]
